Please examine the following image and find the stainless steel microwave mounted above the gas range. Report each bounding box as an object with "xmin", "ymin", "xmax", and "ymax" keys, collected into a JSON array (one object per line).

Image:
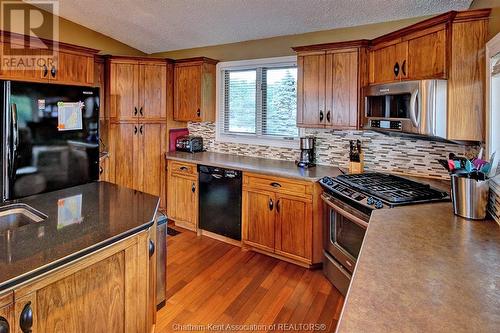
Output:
[{"xmin": 365, "ymin": 80, "xmax": 447, "ymax": 138}]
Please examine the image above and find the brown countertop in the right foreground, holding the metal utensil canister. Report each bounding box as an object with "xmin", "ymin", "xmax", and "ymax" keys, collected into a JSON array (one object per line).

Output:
[{"xmin": 337, "ymin": 202, "xmax": 500, "ymax": 333}]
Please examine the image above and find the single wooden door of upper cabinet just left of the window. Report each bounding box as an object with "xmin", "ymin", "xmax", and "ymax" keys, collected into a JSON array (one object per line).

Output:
[{"xmin": 174, "ymin": 65, "xmax": 202, "ymax": 121}]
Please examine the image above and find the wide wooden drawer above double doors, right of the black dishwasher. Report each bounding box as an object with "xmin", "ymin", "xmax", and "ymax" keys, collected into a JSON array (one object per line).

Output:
[{"xmin": 243, "ymin": 174, "xmax": 313, "ymax": 196}]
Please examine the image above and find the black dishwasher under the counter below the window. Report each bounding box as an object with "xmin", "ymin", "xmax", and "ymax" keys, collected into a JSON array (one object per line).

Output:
[{"xmin": 198, "ymin": 165, "xmax": 242, "ymax": 240}]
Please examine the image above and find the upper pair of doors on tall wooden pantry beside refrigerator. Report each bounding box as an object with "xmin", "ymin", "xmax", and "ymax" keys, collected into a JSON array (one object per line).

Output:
[{"xmin": 107, "ymin": 57, "xmax": 167, "ymax": 122}]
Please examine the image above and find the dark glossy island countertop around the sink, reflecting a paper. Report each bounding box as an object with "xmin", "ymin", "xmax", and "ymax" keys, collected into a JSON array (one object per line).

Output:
[{"xmin": 0, "ymin": 182, "xmax": 159, "ymax": 291}]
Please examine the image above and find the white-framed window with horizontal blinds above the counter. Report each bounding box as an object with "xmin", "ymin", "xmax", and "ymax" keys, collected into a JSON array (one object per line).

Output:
[{"xmin": 216, "ymin": 56, "xmax": 300, "ymax": 147}]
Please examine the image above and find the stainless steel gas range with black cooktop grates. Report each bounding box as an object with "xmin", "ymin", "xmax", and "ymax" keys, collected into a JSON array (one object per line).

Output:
[{"xmin": 319, "ymin": 172, "xmax": 449, "ymax": 295}]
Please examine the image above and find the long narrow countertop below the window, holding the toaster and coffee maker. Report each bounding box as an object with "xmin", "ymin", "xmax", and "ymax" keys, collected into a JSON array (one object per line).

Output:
[{"xmin": 166, "ymin": 151, "xmax": 341, "ymax": 181}]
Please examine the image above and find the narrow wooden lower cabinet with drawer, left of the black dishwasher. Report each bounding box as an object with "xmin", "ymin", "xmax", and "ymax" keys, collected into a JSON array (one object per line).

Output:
[{"xmin": 167, "ymin": 161, "xmax": 198, "ymax": 231}]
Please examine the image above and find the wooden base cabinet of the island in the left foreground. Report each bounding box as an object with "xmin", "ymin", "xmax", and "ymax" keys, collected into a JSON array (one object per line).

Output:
[{"xmin": 0, "ymin": 228, "xmax": 156, "ymax": 333}]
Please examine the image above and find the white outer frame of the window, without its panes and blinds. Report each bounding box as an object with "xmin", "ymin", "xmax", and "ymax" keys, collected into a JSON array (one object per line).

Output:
[{"xmin": 215, "ymin": 56, "xmax": 304, "ymax": 148}]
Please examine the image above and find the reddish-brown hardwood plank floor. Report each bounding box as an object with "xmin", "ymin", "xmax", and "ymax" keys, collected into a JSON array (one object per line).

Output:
[{"xmin": 156, "ymin": 228, "xmax": 344, "ymax": 332}]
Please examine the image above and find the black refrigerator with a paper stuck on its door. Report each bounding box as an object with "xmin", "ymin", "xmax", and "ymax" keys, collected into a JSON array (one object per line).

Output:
[{"xmin": 0, "ymin": 81, "xmax": 99, "ymax": 201}]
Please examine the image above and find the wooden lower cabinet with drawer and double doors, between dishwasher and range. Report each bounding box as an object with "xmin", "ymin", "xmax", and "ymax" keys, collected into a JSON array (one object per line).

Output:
[{"xmin": 242, "ymin": 173, "xmax": 322, "ymax": 266}]
